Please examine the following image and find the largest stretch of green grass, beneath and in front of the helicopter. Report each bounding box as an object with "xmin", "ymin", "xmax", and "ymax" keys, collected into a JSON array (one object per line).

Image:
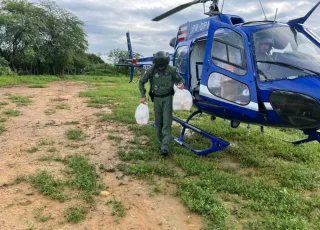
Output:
[{"xmin": 80, "ymin": 77, "xmax": 320, "ymax": 229}]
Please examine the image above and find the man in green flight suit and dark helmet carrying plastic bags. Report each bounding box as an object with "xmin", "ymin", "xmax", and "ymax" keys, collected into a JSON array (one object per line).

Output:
[{"xmin": 139, "ymin": 51, "xmax": 184, "ymax": 156}]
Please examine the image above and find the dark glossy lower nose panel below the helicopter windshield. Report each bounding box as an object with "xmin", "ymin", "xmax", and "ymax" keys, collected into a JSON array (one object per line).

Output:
[{"xmin": 269, "ymin": 90, "xmax": 320, "ymax": 129}]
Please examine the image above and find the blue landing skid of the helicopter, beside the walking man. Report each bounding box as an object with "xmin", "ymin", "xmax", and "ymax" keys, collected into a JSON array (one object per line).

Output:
[{"xmin": 172, "ymin": 110, "xmax": 229, "ymax": 155}]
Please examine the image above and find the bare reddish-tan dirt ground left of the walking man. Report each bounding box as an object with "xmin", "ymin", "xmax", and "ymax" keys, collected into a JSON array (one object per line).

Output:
[{"xmin": 0, "ymin": 82, "xmax": 202, "ymax": 230}]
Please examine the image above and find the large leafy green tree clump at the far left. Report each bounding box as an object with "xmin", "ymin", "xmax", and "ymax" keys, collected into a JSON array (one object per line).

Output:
[{"xmin": 0, "ymin": 0, "xmax": 88, "ymax": 74}]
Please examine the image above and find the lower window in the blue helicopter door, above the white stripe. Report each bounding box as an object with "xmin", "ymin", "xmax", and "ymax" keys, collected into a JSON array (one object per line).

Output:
[{"xmin": 208, "ymin": 73, "xmax": 250, "ymax": 105}]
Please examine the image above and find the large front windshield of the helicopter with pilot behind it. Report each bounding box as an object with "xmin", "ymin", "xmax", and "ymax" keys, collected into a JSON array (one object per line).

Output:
[{"xmin": 253, "ymin": 26, "xmax": 320, "ymax": 81}]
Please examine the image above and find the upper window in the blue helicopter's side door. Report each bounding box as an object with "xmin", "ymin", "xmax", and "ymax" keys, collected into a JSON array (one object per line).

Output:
[{"xmin": 211, "ymin": 28, "xmax": 247, "ymax": 75}]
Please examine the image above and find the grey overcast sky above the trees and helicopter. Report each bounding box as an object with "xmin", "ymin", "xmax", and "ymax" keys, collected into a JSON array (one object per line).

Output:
[{"xmin": 33, "ymin": 0, "xmax": 320, "ymax": 60}]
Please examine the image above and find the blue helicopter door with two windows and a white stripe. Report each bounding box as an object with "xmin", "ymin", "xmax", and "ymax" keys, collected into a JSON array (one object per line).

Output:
[{"xmin": 200, "ymin": 20, "xmax": 258, "ymax": 118}]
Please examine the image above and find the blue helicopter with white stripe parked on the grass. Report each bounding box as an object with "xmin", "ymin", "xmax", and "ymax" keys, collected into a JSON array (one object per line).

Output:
[{"xmin": 115, "ymin": 0, "xmax": 320, "ymax": 155}]
